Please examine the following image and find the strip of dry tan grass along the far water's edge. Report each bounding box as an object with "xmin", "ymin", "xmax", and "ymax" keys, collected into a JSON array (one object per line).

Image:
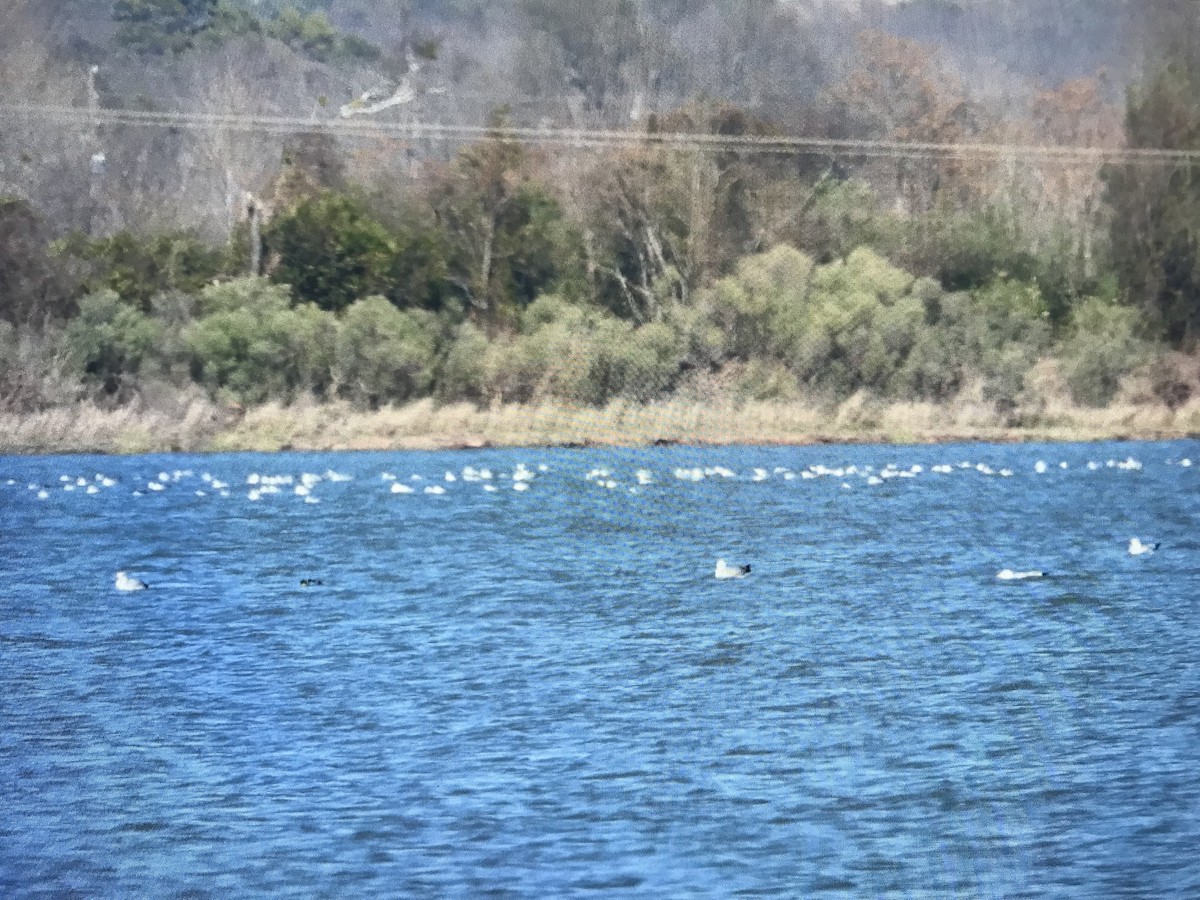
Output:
[{"xmin": 0, "ymin": 397, "xmax": 1200, "ymax": 456}]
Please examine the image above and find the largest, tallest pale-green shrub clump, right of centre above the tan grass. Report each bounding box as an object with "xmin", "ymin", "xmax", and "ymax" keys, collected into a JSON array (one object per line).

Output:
[{"xmin": 701, "ymin": 247, "xmax": 1050, "ymax": 406}]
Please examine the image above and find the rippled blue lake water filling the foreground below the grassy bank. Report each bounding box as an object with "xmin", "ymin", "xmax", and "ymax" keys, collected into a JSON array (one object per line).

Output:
[{"xmin": 0, "ymin": 442, "xmax": 1200, "ymax": 898}]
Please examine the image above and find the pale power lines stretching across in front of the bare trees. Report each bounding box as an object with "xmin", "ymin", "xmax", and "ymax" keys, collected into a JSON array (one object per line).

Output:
[{"xmin": 0, "ymin": 104, "xmax": 1200, "ymax": 166}]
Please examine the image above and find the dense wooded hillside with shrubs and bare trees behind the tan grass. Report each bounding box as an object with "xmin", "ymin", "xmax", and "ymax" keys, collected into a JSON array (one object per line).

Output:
[{"xmin": 0, "ymin": 0, "xmax": 1200, "ymax": 421}]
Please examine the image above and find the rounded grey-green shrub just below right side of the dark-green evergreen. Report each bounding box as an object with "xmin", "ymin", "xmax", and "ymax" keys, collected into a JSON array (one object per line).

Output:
[{"xmin": 334, "ymin": 296, "xmax": 438, "ymax": 407}]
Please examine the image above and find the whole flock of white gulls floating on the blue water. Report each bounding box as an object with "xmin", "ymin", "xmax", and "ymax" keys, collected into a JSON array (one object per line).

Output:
[{"xmin": 4, "ymin": 456, "xmax": 1193, "ymax": 590}]
